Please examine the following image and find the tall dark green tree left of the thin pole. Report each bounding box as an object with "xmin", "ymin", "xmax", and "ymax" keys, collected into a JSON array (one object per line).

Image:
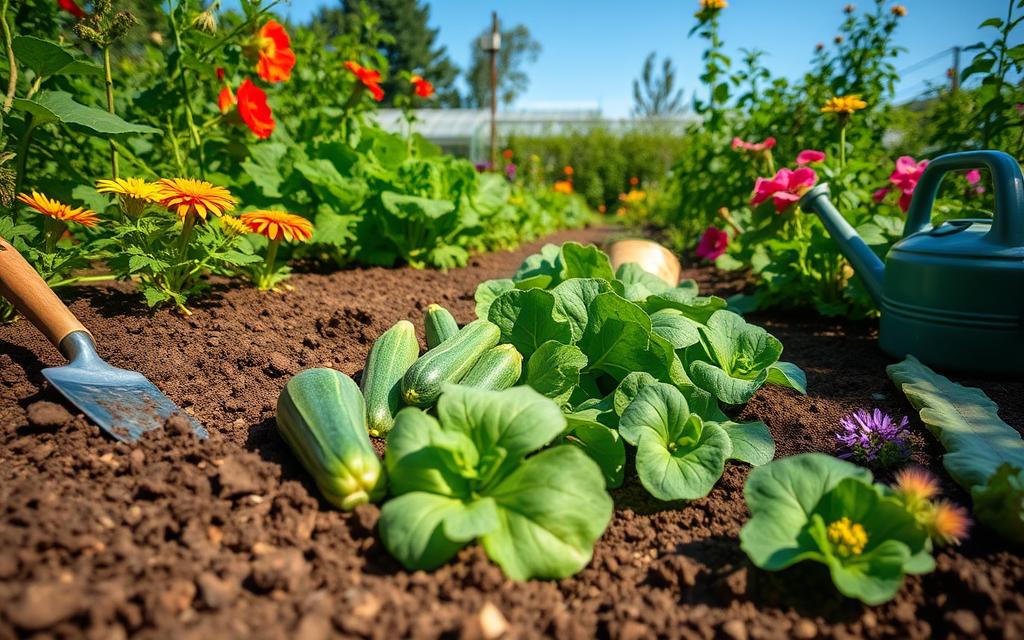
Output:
[{"xmin": 309, "ymin": 0, "xmax": 460, "ymax": 106}]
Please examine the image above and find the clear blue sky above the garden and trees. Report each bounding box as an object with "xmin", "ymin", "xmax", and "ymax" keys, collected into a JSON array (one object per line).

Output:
[{"xmin": 225, "ymin": 0, "xmax": 1009, "ymax": 117}]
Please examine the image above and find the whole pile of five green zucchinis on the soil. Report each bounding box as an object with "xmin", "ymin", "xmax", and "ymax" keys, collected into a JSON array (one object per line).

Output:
[{"xmin": 278, "ymin": 304, "xmax": 522, "ymax": 510}]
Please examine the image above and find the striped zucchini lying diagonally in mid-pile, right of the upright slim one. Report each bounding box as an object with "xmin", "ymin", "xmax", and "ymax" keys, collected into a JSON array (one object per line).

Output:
[{"xmin": 401, "ymin": 319, "xmax": 501, "ymax": 408}]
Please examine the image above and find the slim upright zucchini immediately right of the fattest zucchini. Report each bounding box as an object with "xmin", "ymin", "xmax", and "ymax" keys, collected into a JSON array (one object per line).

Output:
[{"xmin": 360, "ymin": 321, "xmax": 420, "ymax": 436}]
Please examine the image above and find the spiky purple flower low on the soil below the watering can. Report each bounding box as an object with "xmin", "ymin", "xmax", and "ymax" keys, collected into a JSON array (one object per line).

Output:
[{"xmin": 836, "ymin": 409, "xmax": 910, "ymax": 467}]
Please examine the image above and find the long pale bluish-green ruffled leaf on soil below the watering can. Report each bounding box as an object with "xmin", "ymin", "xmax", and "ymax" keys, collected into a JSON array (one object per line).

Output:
[{"xmin": 886, "ymin": 355, "xmax": 1024, "ymax": 543}]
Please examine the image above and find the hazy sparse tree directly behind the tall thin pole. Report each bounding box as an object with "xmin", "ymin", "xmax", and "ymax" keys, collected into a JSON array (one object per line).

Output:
[{"xmin": 465, "ymin": 25, "xmax": 541, "ymax": 109}]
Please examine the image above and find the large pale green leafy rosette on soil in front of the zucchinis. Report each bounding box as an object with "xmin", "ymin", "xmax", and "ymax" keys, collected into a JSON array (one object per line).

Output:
[{"xmin": 379, "ymin": 385, "xmax": 612, "ymax": 580}]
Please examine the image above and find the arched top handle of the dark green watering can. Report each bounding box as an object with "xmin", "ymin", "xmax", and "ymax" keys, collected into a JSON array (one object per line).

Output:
[{"xmin": 903, "ymin": 151, "xmax": 1024, "ymax": 247}]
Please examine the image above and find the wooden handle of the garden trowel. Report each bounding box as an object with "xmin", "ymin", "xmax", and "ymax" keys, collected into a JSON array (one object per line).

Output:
[{"xmin": 0, "ymin": 238, "xmax": 88, "ymax": 349}]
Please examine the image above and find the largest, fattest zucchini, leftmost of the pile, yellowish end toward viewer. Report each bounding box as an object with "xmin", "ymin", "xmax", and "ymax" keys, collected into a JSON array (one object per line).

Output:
[{"xmin": 278, "ymin": 369, "xmax": 387, "ymax": 511}]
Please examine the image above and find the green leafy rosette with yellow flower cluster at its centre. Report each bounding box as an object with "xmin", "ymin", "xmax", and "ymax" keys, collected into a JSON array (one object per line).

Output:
[{"xmin": 739, "ymin": 454, "xmax": 935, "ymax": 604}]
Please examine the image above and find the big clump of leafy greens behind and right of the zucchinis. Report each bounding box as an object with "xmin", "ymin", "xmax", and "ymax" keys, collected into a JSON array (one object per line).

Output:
[{"xmin": 476, "ymin": 243, "xmax": 794, "ymax": 493}]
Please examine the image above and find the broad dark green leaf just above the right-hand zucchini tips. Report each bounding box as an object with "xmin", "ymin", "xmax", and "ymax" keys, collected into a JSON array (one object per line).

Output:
[{"xmin": 487, "ymin": 289, "xmax": 572, "ymax": 361}]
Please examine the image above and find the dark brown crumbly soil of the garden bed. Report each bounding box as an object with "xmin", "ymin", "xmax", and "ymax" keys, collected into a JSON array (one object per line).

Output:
[{"xmin": 0, "ymin": 230, "xmax": 1024, "ymax": 639}]
